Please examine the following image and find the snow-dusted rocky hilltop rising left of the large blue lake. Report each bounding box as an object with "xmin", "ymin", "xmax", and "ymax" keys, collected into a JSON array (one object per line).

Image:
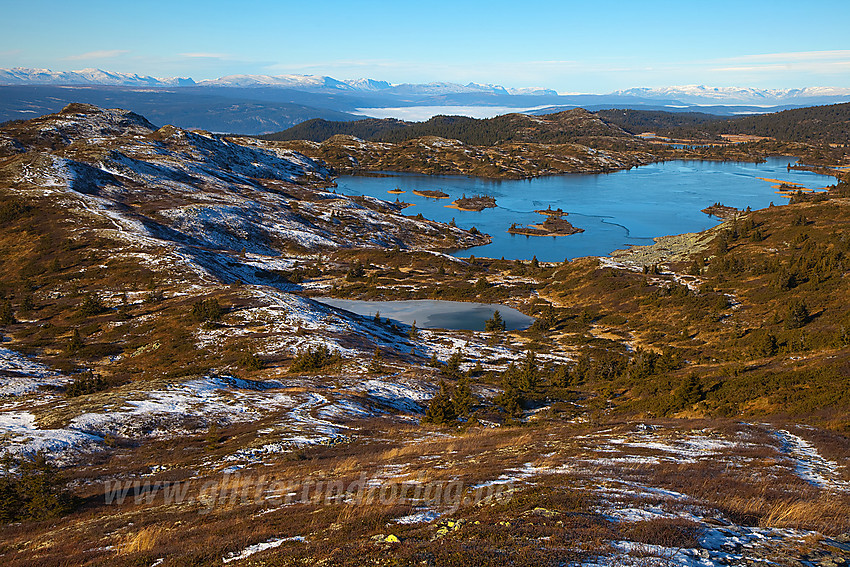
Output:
[{"xmin": 0, "ymin": 104, "xmax": 486, "ymax": 254}]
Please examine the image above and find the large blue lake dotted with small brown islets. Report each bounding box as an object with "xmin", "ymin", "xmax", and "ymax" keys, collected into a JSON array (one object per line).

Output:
[{"xmin": 336, "ymin": 158, "xmax": 835, "ymax": 261}]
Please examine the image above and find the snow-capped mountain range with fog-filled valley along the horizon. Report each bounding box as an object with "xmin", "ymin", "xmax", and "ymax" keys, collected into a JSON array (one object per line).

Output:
[{"xmin": 0, "ymin": 68, "xmax": 850, "ymax": 134}]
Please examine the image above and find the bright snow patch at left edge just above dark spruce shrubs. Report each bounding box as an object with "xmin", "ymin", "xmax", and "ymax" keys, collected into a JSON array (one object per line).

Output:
[{"xmin": 0, "ymin": 411, "xmax": 103, "ymax": 464}]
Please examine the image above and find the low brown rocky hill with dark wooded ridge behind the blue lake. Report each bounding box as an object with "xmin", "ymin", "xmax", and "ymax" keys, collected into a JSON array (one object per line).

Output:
[{"xmin": 274, "ymin": 109, "xmax": 659, "ymax": 179}]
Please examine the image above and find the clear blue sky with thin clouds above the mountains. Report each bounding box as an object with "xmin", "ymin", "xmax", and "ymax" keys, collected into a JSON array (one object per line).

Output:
[{"xmin": 0, "ymin": 0, "xmax": 850, "ymax": 93}]
